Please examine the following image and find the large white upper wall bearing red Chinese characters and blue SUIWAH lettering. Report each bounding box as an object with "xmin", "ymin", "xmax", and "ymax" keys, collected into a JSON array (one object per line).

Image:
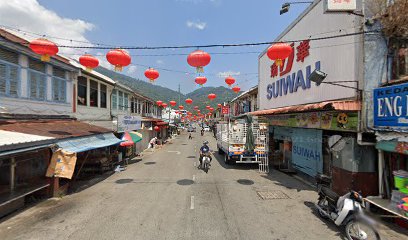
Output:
[{"xmin": 258, "ymin": 1, "xmax": 363, "ymax": 110}]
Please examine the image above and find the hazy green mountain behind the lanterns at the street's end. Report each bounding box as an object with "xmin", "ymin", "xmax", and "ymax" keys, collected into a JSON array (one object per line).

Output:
[{"xmin": 95, "ymin": 67, "xmax": 237, "ymax": 113}]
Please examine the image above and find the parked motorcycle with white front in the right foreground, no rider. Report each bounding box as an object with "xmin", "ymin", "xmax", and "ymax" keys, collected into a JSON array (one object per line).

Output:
[{"xmin": 315, "ymin": 175, "xmax": 381, "ymax": 240}]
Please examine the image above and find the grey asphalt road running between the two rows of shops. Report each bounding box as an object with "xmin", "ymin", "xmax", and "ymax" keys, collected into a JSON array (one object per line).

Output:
[{"xmin": 0, "ymin": 133, "xmax": 402, "ymax": 240}]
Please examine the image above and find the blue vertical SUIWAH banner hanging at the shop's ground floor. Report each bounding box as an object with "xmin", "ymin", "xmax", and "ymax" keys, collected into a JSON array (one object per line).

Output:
[{"xmin": 292, "ymin": 129, "xmax": 323, "ymax": 177}]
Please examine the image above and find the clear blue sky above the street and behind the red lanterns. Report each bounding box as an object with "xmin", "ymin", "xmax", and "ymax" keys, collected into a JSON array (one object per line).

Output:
[{"xmin": 0, "ymin": 0, "xmax": 307, "ymax": 92}]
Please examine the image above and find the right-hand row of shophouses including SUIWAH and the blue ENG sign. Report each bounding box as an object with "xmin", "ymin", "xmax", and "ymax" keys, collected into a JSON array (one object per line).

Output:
[{"xmin": 225, "ymin": 1, "xmax": 408, "ymax": 221}]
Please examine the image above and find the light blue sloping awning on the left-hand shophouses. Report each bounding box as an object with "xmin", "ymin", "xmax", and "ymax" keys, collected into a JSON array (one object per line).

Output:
[{"xmin": 57, "ymin": 133, "xmax": 122, "ymax": 153}]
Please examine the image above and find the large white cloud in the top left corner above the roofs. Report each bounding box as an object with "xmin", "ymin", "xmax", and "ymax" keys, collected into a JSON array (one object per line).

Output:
[{"xmin": 0, "ymin": 0, "xmax": 94, "ymax": 57}]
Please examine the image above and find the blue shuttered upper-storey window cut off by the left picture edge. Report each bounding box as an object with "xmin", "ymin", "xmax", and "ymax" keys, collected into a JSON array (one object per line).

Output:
[{"xmin": 0, "ymin": 48, "xmax": 20, "ymax": 97}]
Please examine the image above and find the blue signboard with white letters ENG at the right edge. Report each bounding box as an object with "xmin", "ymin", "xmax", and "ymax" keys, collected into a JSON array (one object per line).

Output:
[{"xmin": 374, "ymin": 83, "xmax": 408, "ymax": 128}]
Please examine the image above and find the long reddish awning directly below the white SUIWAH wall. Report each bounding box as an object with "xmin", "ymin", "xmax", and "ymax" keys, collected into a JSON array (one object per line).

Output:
[{"xmin": 248, "ymin": 101, "xmax": 361, "ymax": 116}]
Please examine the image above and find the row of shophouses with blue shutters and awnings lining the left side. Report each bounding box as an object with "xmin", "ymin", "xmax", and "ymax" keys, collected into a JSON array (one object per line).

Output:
[{"xmin": 0, "ymin": 27, "xmax": 167, "ymax": 217}]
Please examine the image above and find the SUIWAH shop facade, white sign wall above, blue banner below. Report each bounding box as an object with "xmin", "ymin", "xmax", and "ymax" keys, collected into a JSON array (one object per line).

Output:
[{"xmin": 250, "ymin": 1, "xmax": 378, "ymax": 195}]
